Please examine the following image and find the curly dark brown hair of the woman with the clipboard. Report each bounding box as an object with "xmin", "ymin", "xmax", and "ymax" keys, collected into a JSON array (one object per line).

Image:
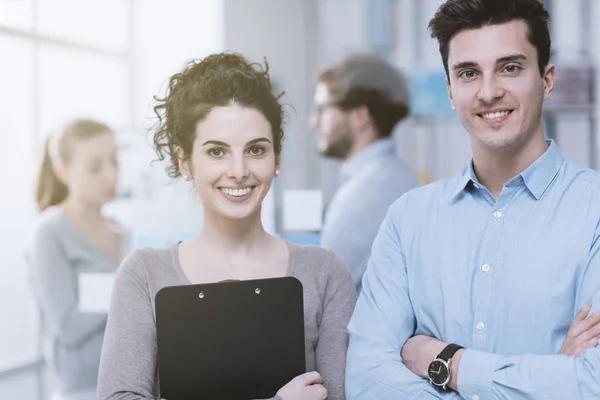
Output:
[{"xmin": 154, "ymin": 53, "xmax": 284, "ymax": 178}]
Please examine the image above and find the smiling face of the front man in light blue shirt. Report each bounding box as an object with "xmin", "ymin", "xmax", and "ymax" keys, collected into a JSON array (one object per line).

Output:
[{"xmin": 446, "ymin": 20, "xmax": 555, "ymax": 152}]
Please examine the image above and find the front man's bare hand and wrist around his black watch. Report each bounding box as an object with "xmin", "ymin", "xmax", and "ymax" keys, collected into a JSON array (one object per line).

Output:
[{"xmin": 400, "ymin": 335, "xmax": 465, "ymax": 391}]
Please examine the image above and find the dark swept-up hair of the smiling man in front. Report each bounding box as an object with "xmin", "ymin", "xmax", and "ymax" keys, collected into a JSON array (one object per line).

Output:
[{"xmin": 429, "ymin": 0, "xmax": 550, "ymax": 79}]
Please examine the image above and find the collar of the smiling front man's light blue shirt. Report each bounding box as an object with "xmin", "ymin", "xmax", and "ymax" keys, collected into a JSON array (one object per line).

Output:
[{"xmin": 451, "ymin": 139, "xmax": 565, "ymax": 200}]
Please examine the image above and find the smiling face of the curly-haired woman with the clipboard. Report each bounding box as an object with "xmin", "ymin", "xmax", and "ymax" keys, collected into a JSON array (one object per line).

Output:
[{"xmin": 179, "ymin": 105, "xmax": 280, "ymax": 219}]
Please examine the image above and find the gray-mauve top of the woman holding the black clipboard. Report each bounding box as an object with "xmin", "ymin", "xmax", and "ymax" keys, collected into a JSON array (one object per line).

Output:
[{"xmin": 98, "ymin": 243, "xmax": 356, "ymax": 400}]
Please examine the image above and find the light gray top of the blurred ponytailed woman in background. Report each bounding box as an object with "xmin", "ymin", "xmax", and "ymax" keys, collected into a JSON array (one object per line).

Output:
[{"xmin": 27, "ymin": 207, "xmax": 129, "ymax": 394}]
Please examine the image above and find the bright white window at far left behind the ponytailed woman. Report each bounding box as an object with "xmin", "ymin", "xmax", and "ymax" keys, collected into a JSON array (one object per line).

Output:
[{"xmin": 0, "ymin": 0, "xmax": 133, "ymax": 371}]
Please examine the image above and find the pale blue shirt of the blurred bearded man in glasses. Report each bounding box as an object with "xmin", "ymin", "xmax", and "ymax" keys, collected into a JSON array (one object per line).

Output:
[{"xmin": 321, "ymin": 138, "xmax": 419, "ymax": 291}]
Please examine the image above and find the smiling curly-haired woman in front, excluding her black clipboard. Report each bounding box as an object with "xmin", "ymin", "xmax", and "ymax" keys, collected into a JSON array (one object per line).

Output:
[{"xmin": 98, "ymin": 54, "xmax": 356, "ymax": 400}]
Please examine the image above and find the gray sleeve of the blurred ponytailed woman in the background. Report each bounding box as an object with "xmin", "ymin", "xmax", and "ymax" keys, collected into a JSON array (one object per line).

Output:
[{"xmin": 28, "ymin": 225, "xmax": 106, "ymax": 348}]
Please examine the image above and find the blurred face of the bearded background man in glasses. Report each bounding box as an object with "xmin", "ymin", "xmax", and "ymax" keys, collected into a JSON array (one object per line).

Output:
[{"xmin": 309, "ymin": 83, "xmax": 354, "ymax": 159}]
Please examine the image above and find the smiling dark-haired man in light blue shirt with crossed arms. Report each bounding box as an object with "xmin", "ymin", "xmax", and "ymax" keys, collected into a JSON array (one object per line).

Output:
[{"xmin": 346, "ymin": 0, "xmax": 600, "ymax": 400}]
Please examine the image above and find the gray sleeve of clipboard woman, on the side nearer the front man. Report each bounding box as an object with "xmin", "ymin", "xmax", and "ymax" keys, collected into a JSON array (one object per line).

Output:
[{"xmin": 315, "ymin": 253, "xmax": 356, "ymax": 400}]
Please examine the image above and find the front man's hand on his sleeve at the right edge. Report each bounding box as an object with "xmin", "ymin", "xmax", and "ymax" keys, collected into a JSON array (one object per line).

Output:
[{"xmin": 558, "ymin": 305, "xmax": 600, "ymax": 356}]
